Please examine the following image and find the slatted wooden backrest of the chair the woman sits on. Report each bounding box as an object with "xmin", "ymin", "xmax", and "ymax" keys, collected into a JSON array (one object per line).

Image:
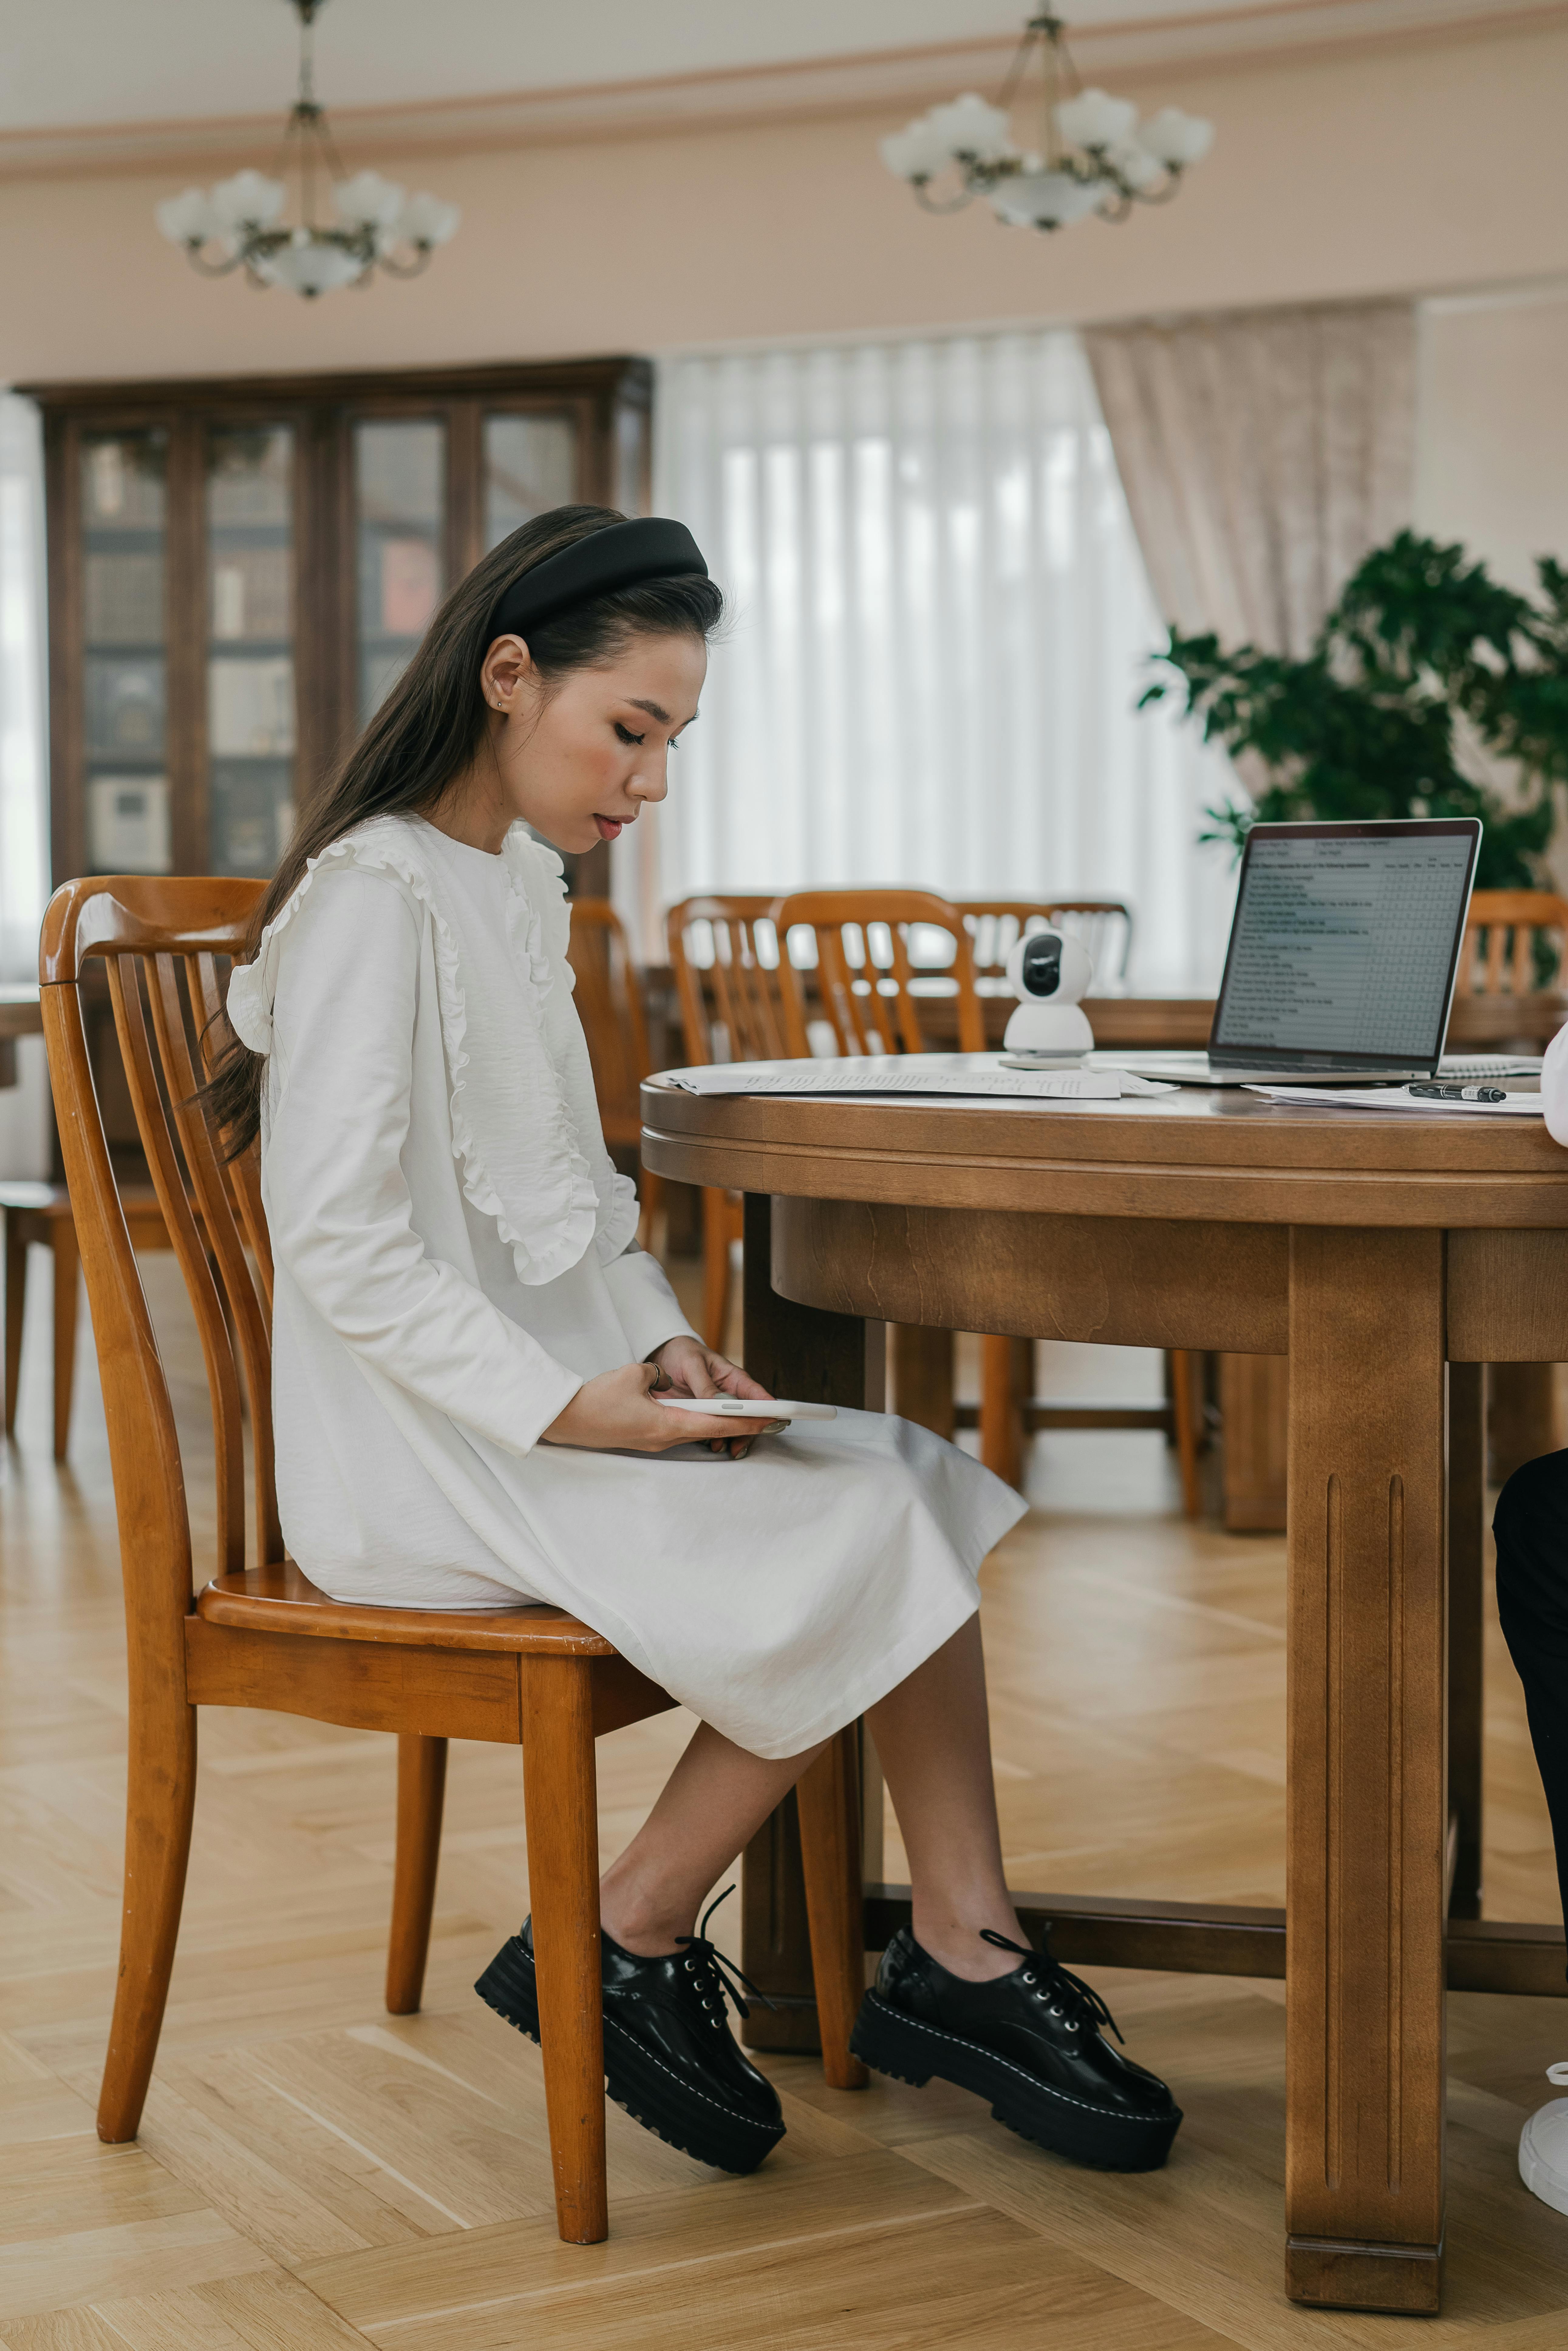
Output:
[{"xmin": 38, "ymin": 875, "xmax": 282, "ymax": 1674}]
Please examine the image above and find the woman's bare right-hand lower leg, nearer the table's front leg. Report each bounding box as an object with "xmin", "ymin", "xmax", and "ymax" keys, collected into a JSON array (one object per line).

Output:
[{"xmin": 865, "ymin": 1615, "xmax": 1027, "ymax": 1982}]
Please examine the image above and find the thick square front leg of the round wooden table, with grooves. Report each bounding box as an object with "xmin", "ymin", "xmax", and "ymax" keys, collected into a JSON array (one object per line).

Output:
[{"xmin": 1286, "ymin": 1227, "xmax": 1448, "ymax": 2311}]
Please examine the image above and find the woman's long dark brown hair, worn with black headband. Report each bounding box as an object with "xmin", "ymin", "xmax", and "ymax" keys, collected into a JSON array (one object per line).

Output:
[{"xmin": 205, "ymin": 506, "xmax": 724, "ymax": 1159}]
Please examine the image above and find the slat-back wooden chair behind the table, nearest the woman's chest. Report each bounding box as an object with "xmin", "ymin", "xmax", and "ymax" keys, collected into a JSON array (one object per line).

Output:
[{"xmin": 665, "ymin": 896, "xmax": 790, "ymax": 1347}]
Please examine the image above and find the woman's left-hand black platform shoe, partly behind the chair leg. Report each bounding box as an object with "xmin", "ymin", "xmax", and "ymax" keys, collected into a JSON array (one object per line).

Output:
[{"xmin": 475, "ymin": 1888, "xmax": 785, "ymax": 2172}]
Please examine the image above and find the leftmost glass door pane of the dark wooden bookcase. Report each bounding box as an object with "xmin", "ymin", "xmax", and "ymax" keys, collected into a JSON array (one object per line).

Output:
[{"xmin": 80, "ymin": 430, "xmax": 172, "ymax": 875}]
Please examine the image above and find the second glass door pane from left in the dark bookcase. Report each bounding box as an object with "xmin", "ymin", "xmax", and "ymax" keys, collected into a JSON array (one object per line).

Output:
[{"xmin": 207, "ymin": 425, "xmax": 296, "ymax": 875}]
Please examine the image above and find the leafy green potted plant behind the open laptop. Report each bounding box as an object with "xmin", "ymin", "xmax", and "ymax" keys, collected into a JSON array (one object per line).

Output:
[{"xmin": 1140, "ymin": 531, "xmax": 1568, "ymax": 889}]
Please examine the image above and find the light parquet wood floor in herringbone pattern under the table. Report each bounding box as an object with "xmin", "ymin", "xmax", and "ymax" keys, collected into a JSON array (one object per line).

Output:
[{"xmin": 0, "ymin": 1258, "xmax": 1568, "ymax": 2351}]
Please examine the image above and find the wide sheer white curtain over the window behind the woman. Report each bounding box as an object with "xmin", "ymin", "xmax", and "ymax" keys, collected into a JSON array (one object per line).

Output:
[{"xmin": 644, "ymin": 332, "xmax": 1234, "ymax": 988}]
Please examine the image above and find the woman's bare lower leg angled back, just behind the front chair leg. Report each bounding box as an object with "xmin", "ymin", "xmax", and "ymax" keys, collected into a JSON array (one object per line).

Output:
[{"xmin": 599, "ymin": 1723, "xmax": 827, "ymax": 1958}]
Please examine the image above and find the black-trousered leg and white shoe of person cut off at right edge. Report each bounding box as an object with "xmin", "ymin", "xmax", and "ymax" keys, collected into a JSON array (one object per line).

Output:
[{"xmin": 1493, "ymin": 1453, "xmax": 1568, "ymax": 2212}]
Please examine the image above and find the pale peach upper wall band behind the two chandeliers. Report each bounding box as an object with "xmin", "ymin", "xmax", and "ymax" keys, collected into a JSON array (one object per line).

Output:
[{"xmin": 0, "ymin": 26, "xmax": 1568, "ymax": 381}]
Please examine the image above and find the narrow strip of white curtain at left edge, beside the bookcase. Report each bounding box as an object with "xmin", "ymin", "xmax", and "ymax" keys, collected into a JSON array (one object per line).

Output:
[{"xmin": 0, "ymin": 393, "xmax": 49, "ymax": 980}]
